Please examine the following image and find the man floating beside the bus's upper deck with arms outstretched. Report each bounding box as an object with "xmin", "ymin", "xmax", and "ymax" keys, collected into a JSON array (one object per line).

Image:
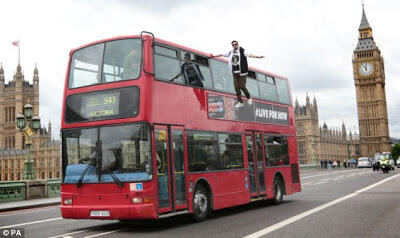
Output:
[{"xmin": 211, "ymin": 40, "xmax": 264, "ymax": 107}]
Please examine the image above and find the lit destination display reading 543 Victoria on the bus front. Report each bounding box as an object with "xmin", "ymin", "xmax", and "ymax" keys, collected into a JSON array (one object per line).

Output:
[{"xmin": 81, "ymin": 92, "xmax": 120, "ymax": 119}]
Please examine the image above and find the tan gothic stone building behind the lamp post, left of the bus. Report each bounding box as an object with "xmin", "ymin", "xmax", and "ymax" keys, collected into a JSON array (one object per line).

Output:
[{"xmin": 0, "ymin": 64, "xmax": 61, "ymax": 181}]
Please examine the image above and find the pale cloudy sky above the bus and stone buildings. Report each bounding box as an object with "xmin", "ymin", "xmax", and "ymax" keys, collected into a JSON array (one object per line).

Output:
[{"xmin": 0, "ymin": 0, "xmax": 400, "ymax": 139}]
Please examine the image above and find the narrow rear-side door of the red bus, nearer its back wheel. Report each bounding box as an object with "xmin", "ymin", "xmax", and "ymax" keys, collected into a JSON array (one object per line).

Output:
[{"xmin": 246, "ymin": 132, "xmax": 265, "ymax": 197}]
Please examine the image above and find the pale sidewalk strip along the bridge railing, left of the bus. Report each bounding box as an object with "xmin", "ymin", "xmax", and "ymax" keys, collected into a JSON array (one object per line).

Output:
[{"xmin": 0, "ymin": 197, "xmax": 60, "ymax": 213}]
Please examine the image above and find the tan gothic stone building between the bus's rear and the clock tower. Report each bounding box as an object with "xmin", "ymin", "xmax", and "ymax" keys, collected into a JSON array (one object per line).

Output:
[{"xmin": 295, "ymin": 95, "xmax": 359, "ymax": 164}]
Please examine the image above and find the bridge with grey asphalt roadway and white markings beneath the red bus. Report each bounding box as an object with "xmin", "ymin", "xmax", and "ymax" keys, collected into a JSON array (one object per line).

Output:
[{"xmin": 0, "ymin": 167, "xmax": 400, "ymax": 238}]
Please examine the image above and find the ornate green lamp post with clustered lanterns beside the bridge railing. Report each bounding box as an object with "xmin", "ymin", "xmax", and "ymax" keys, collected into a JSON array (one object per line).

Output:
[{"xmin": 17, "ymin": 104, "xmax": 40, "ymax": 180}]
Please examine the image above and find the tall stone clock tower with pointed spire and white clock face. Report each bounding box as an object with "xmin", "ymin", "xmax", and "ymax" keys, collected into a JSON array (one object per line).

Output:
[{"xmin": 353, "ymin": 5, "xmax": 391, "ymax": 156}]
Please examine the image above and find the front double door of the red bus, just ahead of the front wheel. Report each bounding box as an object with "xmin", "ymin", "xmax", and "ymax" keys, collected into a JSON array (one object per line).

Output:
[{"xmin": 154, "ymin": 125, "xmax": 187, "ymax": 213}]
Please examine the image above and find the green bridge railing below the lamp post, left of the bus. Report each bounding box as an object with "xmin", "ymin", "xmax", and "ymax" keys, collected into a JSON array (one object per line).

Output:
[{"xmin": 0, "ymin": 179, "xmax": 61, "ymax": 203}]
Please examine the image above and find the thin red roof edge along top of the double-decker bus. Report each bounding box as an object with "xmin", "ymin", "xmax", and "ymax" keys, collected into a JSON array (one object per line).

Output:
[{"xmin": 70, "ymin": 35, "xmax": 287, "ymax": 80}]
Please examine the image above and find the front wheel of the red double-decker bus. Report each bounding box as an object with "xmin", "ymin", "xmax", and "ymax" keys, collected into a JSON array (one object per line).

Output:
[{"xmin": 193, "ymin": 184, "xmax": 210, "ymax": 221}]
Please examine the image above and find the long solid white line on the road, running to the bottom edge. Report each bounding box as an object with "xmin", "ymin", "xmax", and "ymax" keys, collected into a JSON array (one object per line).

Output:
[{"xmin": 243, "ymin": 174, "xmax": 400, "ymax": 238}]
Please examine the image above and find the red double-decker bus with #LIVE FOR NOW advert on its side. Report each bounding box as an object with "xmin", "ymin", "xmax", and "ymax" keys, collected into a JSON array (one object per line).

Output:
[{"xmin": 61, "ymin": 32, "xmax": 301, "ymax": 220}]
